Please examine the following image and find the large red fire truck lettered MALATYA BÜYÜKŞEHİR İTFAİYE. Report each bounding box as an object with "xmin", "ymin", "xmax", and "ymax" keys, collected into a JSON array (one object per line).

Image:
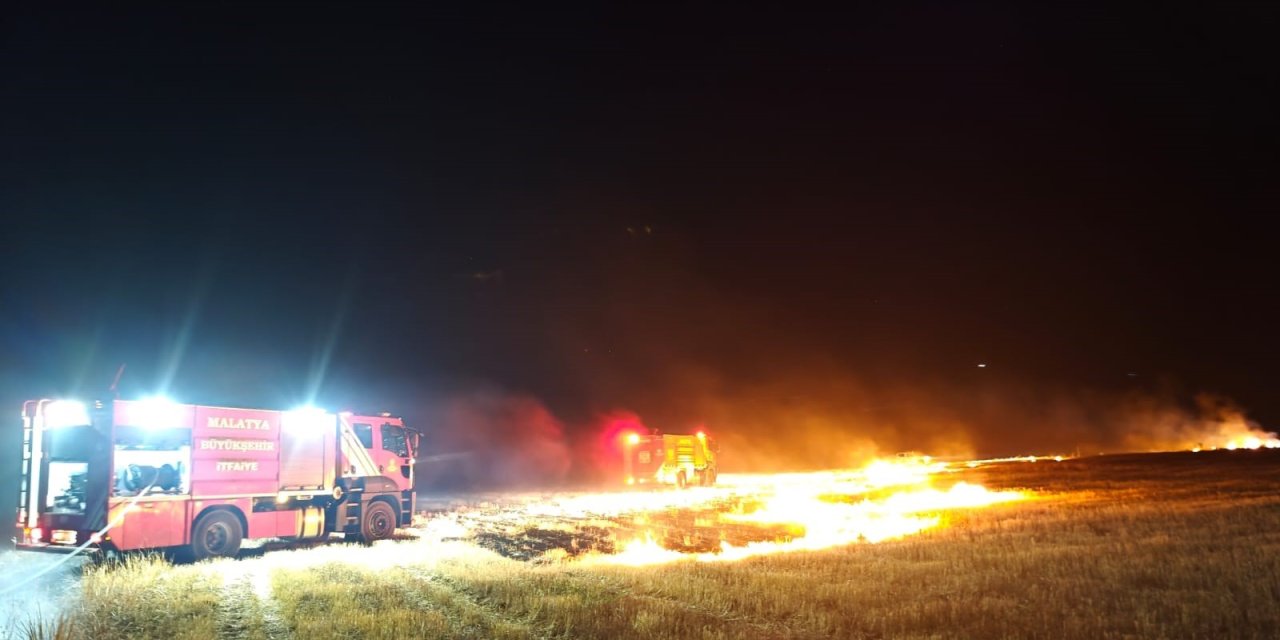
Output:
[{"xmin": 17, "ymin": 399, "xmax": 417, "ymax": 559}]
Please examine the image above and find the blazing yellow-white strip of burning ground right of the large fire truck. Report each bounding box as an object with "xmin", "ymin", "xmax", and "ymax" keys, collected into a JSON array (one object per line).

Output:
[{"xmin": 413, "ymin": 462, "xmax": 1029, "ymax": 564}]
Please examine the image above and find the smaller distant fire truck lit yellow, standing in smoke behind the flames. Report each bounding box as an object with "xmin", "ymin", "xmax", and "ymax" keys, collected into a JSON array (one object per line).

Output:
[{"xmin": 622, "ymin": 431, "xmax": 719, "ymax": 488}]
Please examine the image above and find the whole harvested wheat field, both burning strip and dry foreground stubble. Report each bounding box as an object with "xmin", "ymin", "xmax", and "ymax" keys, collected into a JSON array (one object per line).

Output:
[{"xmin": 10, "ymin": 451, "xmax": 1280, "ymax": 639}]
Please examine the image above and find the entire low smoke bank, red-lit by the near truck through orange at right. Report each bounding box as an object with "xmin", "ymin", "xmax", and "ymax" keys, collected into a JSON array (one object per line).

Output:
[{"xmin": 404, "ymin": 369, "xmax": 1280, "ymax": 490}]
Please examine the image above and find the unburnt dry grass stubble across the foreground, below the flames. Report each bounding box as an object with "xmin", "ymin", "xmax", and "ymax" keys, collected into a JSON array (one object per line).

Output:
[{"xmin": 10, "ymin": 452, "xmax": 1280, "ymax": 639}]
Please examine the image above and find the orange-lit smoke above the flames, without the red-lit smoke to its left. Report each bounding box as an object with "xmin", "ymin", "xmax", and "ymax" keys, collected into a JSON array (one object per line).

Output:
[{"xmin": 552, "ymin": 360, "xmax": 1280, "ymax": 471}]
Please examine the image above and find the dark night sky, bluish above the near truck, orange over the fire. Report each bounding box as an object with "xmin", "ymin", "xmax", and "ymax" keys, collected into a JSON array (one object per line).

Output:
[{"xmin": 0, "ymin": 3, "xmax": 1280, "ymax": 488}]
